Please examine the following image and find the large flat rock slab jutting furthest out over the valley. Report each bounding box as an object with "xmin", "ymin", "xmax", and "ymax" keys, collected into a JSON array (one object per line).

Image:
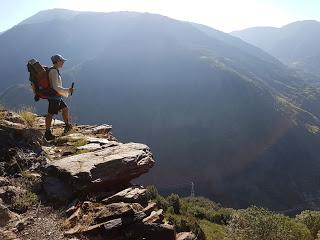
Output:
[{"xmin": 47, "ymin": 143, "xmax": 154, "ymax": 191}]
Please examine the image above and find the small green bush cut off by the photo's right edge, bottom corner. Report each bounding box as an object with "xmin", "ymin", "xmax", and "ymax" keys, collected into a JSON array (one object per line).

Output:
[{"xmin": 296, "ymin": 210, "xmax": 320, "ymax": 238}]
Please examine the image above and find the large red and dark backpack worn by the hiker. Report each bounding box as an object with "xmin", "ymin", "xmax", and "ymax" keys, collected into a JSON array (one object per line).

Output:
[{"xmin": 27, "ymin": 59, "xmax": 60, "ymax": 101}]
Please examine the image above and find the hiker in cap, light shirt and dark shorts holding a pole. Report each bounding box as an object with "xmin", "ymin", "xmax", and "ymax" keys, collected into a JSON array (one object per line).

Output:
[{"xmin": 44, "ymin": 54, "xmax": 73, "ymax": 141}]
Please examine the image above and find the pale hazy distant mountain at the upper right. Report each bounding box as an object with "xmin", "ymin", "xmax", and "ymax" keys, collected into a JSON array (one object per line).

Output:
[{"xmin": 231, "ymin": 20, "xmax": 320, "ymax": 74}]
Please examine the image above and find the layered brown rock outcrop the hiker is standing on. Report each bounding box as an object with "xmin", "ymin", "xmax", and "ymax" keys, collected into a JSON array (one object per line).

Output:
[{"xmin": 0, "ymin": 111, "xmax": 189, "ymax": 240}]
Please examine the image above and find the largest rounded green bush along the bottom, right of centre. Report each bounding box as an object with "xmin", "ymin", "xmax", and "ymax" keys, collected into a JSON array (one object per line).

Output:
[{"xmin": 227, "ymin": 207, "xmax": 312, "ymax": 240}]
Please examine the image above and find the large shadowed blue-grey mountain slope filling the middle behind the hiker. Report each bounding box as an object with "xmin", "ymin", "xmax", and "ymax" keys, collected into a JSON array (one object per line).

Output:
[{"xmin": 0, "ymin": 10, "xmax": 320, "ymax": 209}]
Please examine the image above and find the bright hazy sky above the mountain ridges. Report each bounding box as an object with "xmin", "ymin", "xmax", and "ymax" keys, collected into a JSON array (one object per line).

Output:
[{"xmin": 0, "ymin": 0, "xmax": 320, "ymax": 32}]
